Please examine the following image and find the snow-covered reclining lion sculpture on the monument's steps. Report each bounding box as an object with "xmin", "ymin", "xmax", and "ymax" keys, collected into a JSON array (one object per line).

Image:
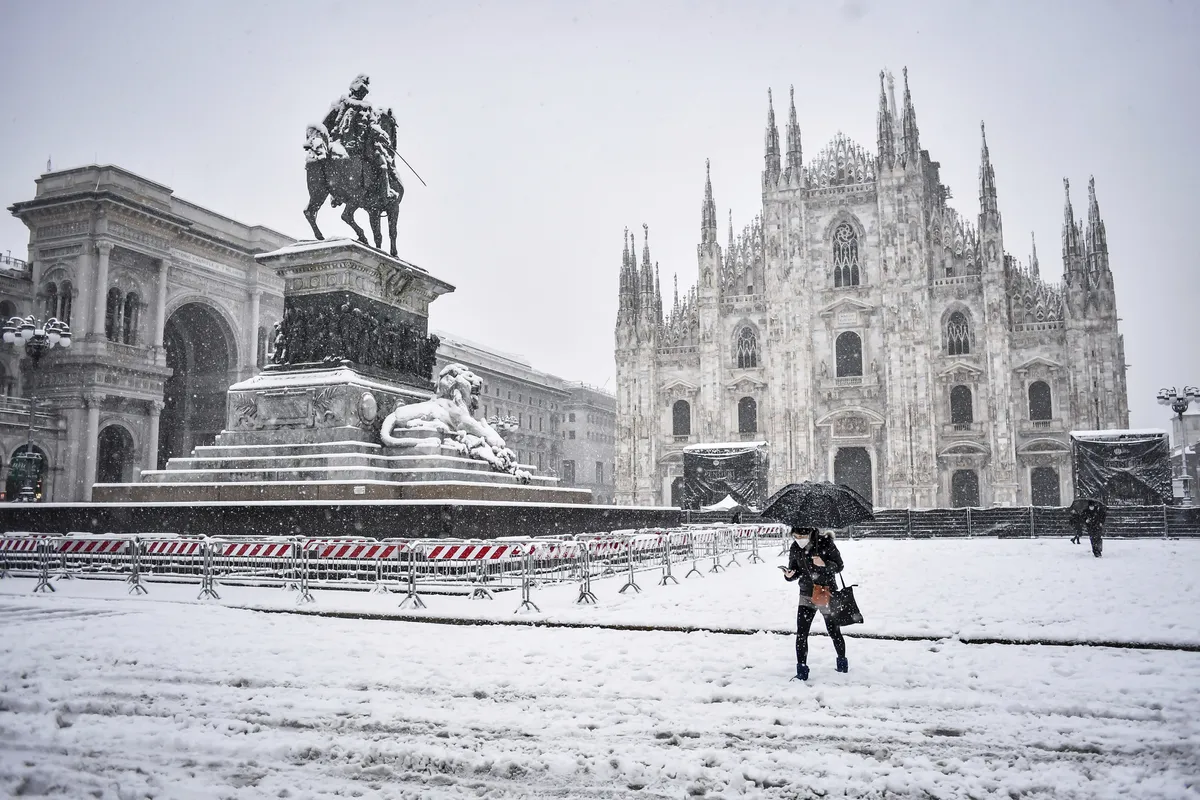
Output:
[{"xmin": 379, "ymin": 363, "xmax": 530, "ymax": 483}]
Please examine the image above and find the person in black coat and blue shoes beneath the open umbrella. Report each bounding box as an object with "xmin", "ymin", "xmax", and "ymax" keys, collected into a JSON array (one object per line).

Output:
[{"xmin": 784, "ymin": 528, "xmax": 850, "ymax": 680}]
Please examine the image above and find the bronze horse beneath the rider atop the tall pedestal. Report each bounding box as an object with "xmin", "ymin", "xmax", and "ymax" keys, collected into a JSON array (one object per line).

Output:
[{"xmin": 304, "ymin": 110, "xmax": 404, "ymax": 255}]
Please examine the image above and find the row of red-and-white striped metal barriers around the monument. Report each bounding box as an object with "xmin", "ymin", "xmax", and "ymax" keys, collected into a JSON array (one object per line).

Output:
[{"xmin": 0, "ymin": 524, "xmax": 786, "ymax": 612}]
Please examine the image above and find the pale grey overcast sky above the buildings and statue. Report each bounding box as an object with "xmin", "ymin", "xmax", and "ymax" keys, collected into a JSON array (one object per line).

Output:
[{"xmin": 0, "ymin": 0, "xmax": 1200, "ymax": 427}]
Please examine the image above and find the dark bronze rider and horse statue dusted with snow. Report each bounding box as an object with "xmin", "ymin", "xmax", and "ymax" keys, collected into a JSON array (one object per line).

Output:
[{"xmin": 304, "ymin": 74, "xmax": 420, "ymax": 255}]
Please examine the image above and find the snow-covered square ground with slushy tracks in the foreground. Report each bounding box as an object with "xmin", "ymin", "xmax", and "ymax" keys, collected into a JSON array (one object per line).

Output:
[{"xmin": 0, "ymin": 540, "xmax": 1200, "ymax": 799}]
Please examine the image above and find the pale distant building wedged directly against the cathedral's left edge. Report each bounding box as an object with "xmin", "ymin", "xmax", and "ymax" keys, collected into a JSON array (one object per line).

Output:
[{"xmin": 559, "ymin": 383, "xmax": 617, "ymax": 504}]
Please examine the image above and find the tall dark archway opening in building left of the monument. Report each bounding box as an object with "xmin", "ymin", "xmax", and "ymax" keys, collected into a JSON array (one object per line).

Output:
[{"xmin": 158, "ymin": 302, "xmax": 236, "ymax": 469}]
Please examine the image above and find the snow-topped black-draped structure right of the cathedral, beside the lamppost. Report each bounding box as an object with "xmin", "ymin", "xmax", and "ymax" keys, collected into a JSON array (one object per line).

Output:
[{"xmin": 1070, "ymin": 432, "xmax": 1172, "ymax": 506}]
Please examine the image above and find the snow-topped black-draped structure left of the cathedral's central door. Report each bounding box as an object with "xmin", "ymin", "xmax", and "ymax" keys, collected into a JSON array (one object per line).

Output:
[{"xmin": 682, "ymin": 443, "xmax": 767, "ymax": 511}]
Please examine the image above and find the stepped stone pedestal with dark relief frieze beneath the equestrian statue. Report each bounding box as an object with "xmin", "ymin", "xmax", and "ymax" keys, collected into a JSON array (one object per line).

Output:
[{"xmin": 92, "ymin": 239, "xmax": 592, "ymax": 504}]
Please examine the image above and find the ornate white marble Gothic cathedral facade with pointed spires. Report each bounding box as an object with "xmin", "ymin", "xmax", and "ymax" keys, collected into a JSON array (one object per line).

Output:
[{"xmin": 616, "ymin": 71, "xmax": 1129, "ymax": 507}]
